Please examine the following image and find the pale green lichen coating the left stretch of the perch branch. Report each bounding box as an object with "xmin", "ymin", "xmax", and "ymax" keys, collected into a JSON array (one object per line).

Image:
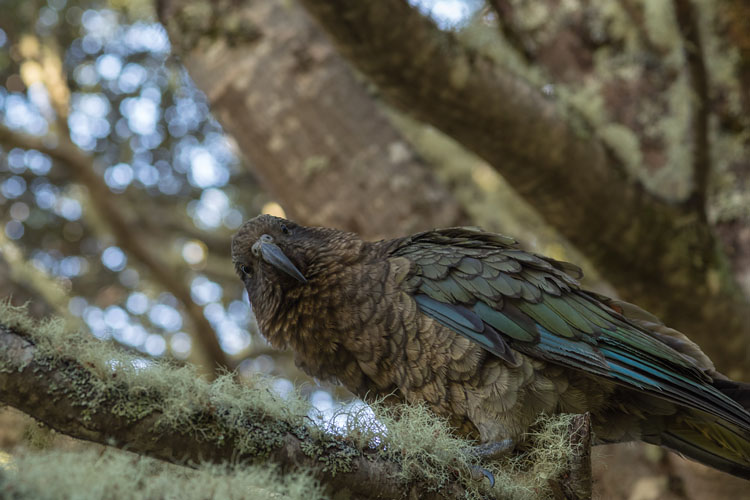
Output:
[{"xmin": 0, "ymin": 302, "xmax": 309, "ymax": 456}]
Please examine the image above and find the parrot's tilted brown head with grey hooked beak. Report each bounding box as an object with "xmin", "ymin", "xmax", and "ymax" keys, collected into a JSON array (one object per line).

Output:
[{"xmin": 232, "ymin": 211, "xmax": 362, "ymax": 301}]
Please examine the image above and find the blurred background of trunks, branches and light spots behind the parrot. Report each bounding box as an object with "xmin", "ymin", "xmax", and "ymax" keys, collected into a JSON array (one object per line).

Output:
[{"xmin": 0, "ymin": 0, "xmax": 750, "ymax": 498}]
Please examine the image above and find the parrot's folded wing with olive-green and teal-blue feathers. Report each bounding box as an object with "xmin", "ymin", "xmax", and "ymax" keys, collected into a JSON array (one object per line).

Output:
[{"xmin": 394, "ymin": 228, "xmax": 750, "ymax": 428}]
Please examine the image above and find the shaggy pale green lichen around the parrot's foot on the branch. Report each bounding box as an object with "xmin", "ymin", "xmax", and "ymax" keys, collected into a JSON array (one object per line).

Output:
[{"xmin": 320, "ymin": 402, "xmax": 579, "ymax": 500}]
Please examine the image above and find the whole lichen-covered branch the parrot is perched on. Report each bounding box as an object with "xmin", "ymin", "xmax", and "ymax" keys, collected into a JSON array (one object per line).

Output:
[{"xmin": 0, "ymin": 302, "xmax": 590, "ymax": 499}]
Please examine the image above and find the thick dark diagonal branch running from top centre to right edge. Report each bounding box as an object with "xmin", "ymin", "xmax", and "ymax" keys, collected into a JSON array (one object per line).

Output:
[{"xmin": 301, "ymin": 0, "xmax": 750, "ymax": 376}]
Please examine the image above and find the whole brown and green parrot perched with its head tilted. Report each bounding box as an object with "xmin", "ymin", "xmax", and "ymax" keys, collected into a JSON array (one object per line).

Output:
[{"xmin": 232, "ymin": 215, "xmax": 750, "ymax": 479}]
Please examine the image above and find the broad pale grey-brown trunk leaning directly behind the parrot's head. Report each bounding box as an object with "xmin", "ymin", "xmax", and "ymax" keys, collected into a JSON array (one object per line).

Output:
[{"xmin": 159, "ymin": 0, "xmax": 467, "ymax": 238}]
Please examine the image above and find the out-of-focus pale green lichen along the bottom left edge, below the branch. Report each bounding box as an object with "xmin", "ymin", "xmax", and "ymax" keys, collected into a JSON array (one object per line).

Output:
[{"xmin": 0, "ymin": 449, "xmax": 325, "ymax": 500}]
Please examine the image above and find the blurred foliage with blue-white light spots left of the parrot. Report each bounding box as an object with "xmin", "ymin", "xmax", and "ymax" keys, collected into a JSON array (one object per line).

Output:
[{"xmin": 0, "ymin": 0, "xmax": 268, "ymax": 364}]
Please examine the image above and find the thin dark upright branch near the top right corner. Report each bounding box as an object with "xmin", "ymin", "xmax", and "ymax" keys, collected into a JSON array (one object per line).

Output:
[{"xmin": 673, "ymin": 0, "xmax": 711, "ymax": 220}]
